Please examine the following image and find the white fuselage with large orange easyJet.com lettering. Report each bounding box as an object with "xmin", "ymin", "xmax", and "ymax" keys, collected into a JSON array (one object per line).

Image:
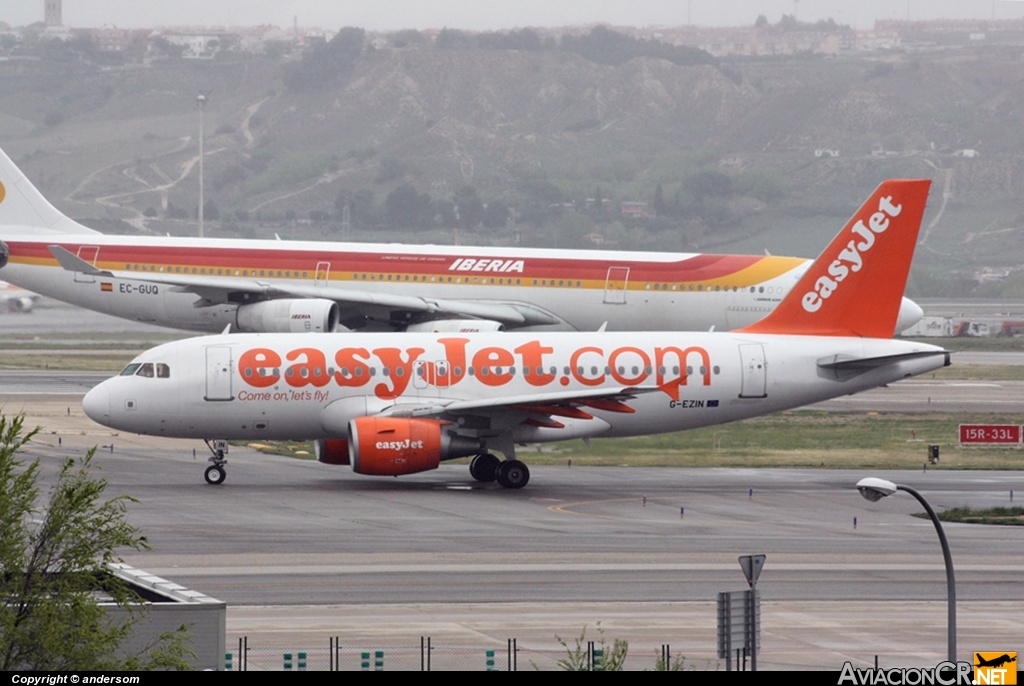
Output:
[{"xmin": 84, "ymin": 333, "xmax": 948, "ymax": 442}]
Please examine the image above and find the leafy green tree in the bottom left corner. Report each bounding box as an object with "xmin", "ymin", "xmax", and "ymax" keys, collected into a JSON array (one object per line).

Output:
[{"xmin": 0, "ymin": 416, "xmax": 191, "ymax": 672}]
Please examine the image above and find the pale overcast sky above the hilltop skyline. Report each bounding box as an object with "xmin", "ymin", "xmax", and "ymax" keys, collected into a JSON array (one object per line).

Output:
[{"xmin": 0, "ymin": 0, "xmax": 1024, "ymax": 31}]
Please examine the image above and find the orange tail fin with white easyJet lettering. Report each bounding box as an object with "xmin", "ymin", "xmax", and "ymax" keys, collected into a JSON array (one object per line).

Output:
[{"xmin": 738, "ymin": 179, "xmax": 932, "ymax": 338}]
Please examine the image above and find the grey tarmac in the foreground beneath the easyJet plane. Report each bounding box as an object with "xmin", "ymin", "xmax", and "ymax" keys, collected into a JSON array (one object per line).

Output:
[{"xmin": 9, "ymin": 395, "xmax": 1024, "ymax": 670}]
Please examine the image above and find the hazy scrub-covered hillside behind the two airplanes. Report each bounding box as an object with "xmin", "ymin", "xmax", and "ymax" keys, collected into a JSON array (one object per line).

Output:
[{"xmin": 0, "ymin": 40, "xmax": 1024, "ymax": 292}]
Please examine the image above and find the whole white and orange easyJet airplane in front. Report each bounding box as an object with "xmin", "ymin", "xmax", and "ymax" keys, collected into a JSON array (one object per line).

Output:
[{"xmin": 83, "ymin": 180, "xmax": 949, "ymax": 488}]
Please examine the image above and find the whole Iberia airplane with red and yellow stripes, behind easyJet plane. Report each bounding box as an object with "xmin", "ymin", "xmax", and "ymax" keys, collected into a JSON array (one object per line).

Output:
[{"xmin": 0, "ymin": 151, "xmax": 923, "ymax": 333}]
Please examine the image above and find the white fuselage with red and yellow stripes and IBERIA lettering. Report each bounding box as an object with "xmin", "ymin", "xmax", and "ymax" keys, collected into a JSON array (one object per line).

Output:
[{"xmin": 0, "ymin": 227, "xmax": 809, "ymax": 332}]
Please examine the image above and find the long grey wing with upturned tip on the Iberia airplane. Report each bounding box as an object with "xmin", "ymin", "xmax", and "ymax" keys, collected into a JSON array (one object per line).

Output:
[{"xmin": 49, "ymin": 245, "xmax": 563, "ymax": 328}]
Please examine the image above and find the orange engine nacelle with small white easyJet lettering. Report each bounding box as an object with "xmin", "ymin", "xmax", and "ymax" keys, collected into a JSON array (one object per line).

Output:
[{"xmin": 348, "ymin": 417, "xmax": 481, "ymax": 476}]
